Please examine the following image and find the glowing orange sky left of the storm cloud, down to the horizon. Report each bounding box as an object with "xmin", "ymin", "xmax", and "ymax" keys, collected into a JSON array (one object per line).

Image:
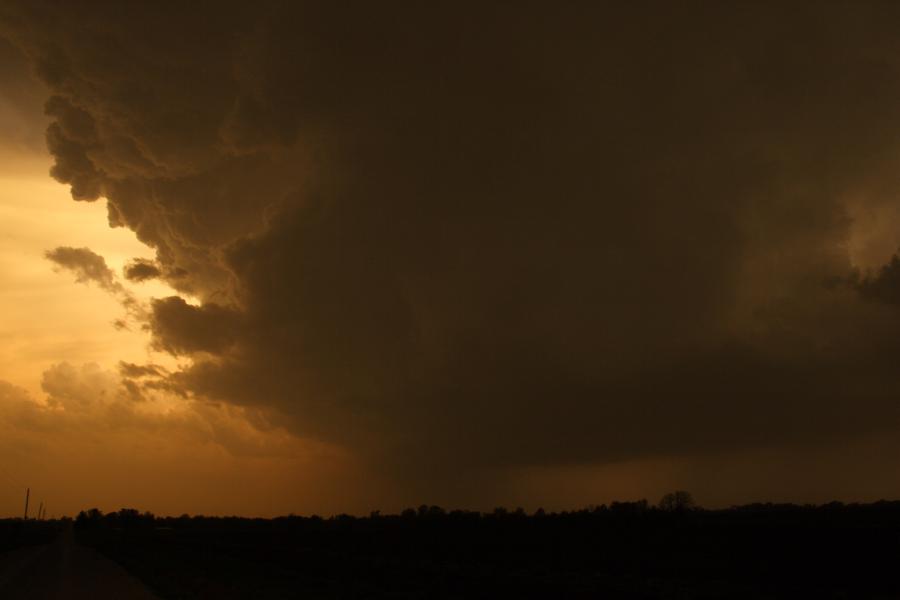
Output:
[{"xmin": 0, "ymin": 154, "xmax": 356, "ymax": 515}]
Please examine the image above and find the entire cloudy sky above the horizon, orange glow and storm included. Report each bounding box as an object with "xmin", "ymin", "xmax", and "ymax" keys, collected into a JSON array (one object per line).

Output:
[{"xmin": 0, "ymin": 0, "xmax": 900, "ymax": 516}]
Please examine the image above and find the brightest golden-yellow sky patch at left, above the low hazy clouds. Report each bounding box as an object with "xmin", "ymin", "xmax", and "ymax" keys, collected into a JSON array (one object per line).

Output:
[{"xmin": 0, "ymin": 157, "xmax": 164, "ymax": 395}]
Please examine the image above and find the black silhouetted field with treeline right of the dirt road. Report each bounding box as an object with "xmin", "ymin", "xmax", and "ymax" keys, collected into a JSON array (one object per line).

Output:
[{"xmin": 76, "ymin": 502, "xmax": 900, "ymax": 599}]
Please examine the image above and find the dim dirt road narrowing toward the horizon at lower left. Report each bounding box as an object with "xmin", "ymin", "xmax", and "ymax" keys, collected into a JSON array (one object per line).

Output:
[{"xmin": 0, "ymin": 527, "xmax": 159, "ymax": 600}]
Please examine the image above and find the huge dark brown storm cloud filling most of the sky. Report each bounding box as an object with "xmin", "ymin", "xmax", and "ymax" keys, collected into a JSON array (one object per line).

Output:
[{"xmin": 3, "ymin": 2, "xmax": 900, "ymax": 492}]
